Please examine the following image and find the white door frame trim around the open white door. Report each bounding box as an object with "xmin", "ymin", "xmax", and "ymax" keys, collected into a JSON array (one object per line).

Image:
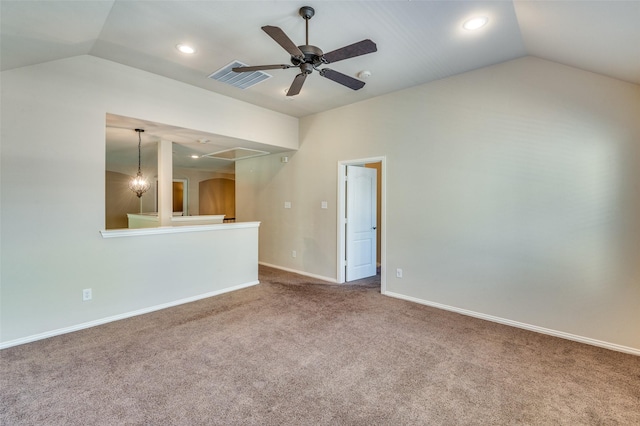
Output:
[{"xmin": 336, "ymin": 156, "xmax": 387, "ymax": 294}]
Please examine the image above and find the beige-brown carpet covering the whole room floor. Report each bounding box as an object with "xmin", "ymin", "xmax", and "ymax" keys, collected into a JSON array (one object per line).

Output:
[{"xmin": 0, "ymin": 268, "xmax": 640, "ymax": 425}]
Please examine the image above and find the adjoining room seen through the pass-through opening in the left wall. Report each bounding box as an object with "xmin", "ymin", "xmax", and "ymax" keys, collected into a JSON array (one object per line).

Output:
[{"xmin": 105, "ymin": 114, "xmax": 271, "ymax": 229}]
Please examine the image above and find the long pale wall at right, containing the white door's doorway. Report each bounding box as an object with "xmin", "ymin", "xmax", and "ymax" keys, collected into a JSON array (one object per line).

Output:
[{"xmin": 236, "ymin": 57, "xmax": 640, "ymax": 352}]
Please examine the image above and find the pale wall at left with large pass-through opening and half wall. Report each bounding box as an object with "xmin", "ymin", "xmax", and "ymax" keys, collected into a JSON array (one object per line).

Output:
[{"xmin": 0, "ymin": 56, "xmax": 298, "ymax": 345}]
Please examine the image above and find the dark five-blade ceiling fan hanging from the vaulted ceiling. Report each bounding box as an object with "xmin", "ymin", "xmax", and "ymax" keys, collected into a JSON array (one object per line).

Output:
[{"xmin": 233, "ymin": 6, "xmax": 378, "ymax": 96}]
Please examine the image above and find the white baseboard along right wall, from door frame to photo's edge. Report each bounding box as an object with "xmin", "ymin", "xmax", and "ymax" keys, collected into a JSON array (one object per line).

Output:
[{"xmin": 383, "ymin": 291, "xmax": 640, "ymax": 356}]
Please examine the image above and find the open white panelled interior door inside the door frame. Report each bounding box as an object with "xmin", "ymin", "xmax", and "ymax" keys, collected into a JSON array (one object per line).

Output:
[{"xmin": 346, "ymin": 166, "xmax": 377, "ymax": 281}]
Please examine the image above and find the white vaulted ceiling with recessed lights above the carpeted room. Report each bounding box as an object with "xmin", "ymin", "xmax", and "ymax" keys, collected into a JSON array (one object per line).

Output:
[{"xmin": 0, "ymin": 0, "xmax": 640, "ymax": 117}]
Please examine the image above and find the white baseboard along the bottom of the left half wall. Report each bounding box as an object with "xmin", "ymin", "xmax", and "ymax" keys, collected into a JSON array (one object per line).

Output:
[{"xmin": 0, "ymin": 280, "xmax": 260, "ymax": 350}]
